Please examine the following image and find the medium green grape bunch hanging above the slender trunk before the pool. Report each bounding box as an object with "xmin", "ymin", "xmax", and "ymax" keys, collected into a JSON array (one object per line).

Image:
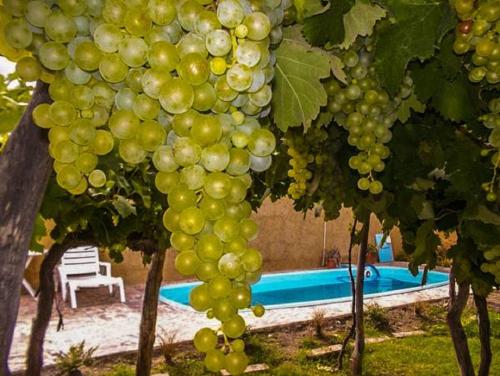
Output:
[{"xmin": 324, "ymin": 50, "xmax": 396, "ymax": 194}]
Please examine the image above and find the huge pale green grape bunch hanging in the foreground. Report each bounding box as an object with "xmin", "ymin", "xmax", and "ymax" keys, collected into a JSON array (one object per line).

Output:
[{"xmin": 1, "ymin": 0, "xmax": 285, "ymax": 374}]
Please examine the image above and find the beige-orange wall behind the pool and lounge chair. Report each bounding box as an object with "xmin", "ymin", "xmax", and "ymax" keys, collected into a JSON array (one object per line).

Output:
[{"xmin": 27, "ymin": 199, "xmax": 401, "ymax": 285}]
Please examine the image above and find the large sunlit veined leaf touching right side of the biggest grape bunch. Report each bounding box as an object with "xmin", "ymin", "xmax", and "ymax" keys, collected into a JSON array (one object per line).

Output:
[{"xmin": 272, "ymin": 39, "xmax": 330, "ymax": 132}]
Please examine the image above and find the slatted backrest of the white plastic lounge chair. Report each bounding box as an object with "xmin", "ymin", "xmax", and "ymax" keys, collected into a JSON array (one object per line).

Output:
[{"xmin": 61, "ymin": 246, "xmax": 99, "ymax": 275}]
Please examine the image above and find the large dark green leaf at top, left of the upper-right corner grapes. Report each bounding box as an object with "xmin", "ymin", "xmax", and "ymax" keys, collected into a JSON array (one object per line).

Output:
[{"xmin": 374, "ymin": 0, "xmax": 450, "ymax": 95}]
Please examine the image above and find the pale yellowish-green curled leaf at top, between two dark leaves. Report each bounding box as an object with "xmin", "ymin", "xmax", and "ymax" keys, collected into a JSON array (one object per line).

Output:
[{"xmin": 340, "ymin": 0, "xmax": 387, "ymax": 49}]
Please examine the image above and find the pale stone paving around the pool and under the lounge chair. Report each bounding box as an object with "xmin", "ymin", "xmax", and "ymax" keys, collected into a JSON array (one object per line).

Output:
[{"xmin": 9, "ymin": 286, "xmax": 448, "ymax": 371}]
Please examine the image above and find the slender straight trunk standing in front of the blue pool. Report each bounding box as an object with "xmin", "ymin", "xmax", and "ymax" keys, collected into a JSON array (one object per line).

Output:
[{"xmin": 351, "ymin": 215, "xmax": 370, "ymax": 376}]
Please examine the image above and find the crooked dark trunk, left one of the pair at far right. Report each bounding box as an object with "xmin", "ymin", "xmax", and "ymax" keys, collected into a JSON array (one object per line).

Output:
[{"xmin": 446, "ymin": 271, "xmax": 474, "ymax": 376}]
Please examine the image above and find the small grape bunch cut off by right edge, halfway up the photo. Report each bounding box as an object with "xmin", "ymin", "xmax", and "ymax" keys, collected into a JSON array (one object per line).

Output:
[{"xmin": 479, "ymin": 98, "xmax": 500, "ymax": 202}]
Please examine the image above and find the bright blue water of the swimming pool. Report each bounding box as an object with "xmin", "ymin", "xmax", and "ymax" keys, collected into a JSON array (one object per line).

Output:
[{"xmin": 160, "ymin": 266, "xmax": 448, "ymax": 308}]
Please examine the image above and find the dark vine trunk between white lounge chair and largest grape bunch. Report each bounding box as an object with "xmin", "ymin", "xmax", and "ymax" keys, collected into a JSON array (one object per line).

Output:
[{"xmin": 135, "ymin": 250, "xmax": 165, "ymax": 376}]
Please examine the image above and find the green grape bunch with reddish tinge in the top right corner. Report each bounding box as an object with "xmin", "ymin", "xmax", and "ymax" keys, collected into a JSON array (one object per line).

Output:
[{"xmin": 453, "ymin": 0, "xmax": 500, "ymax": 84}]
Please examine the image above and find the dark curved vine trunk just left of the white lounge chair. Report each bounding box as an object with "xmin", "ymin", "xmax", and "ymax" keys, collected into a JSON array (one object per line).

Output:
[{"xmin": 26, "ymin": 243, "xmax": 69, "ymax": 376}]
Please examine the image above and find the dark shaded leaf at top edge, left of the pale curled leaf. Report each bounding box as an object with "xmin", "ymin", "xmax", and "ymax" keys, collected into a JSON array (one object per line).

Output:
[{"xmin": 302, "ymin": 0, "xmax": 354, "ymax": 46}]
